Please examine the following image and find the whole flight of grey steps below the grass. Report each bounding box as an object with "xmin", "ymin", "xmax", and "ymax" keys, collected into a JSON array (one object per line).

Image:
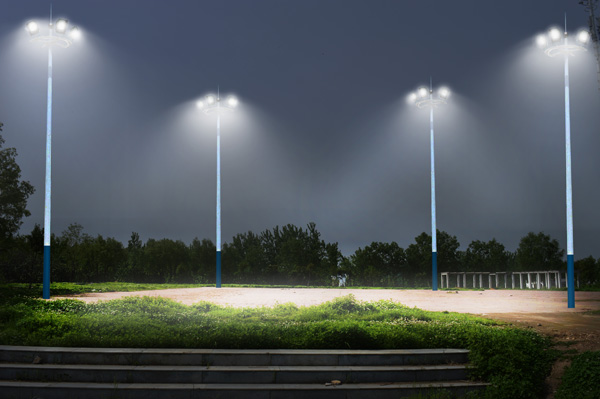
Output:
[{"xmin": 0, "ymin": 346, "xmax": 487, "ymax": 399}]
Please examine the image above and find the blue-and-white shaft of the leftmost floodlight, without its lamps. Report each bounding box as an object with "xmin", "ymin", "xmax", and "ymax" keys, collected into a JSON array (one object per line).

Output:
[{"xmin": 42, "ymin": 44, "xmax": 52, "ymax": 299}]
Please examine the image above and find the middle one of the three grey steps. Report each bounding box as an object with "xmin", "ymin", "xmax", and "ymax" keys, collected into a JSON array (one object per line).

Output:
[{"xmin": 0, "ymin": 363, "xmax": 468, "ymax": 384}]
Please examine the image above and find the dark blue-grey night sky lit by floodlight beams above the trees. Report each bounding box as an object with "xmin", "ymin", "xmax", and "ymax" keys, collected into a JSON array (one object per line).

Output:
[{"xmin": 0, "ymin": 0, "xmax": 600, "ymax": 259}]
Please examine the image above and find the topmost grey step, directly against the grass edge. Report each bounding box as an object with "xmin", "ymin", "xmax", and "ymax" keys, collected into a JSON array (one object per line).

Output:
[{"xmin": 0, "ymin": 345, "xmax": 469, "ymax": 366}]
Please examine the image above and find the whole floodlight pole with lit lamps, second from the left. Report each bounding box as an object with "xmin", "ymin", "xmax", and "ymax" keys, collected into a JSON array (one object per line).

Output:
[{"xmin": 196, "ymin": 94, "xmax": 238, "ymax": 288}]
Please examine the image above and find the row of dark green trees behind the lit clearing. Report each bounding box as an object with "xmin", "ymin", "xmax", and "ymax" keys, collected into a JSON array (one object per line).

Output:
[{"xmin": 0, "ymin": 123, "xmax": 600, "ymax": 287}]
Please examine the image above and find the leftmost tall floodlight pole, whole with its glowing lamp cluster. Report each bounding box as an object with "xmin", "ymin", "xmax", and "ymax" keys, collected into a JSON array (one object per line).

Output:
[{"xmin": 25, "ymin": 9, "xmax": 81, "ymax": 299}]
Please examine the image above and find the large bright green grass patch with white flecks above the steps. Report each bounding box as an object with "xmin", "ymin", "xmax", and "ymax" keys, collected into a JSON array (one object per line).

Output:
[{"xmin": 0, "ymin": 287, "xmax": 554, "ymax": 399}]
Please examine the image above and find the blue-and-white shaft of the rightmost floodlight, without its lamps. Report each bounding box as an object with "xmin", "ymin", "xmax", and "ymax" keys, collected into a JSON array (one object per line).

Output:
[{"xmin": 565, "ymin": 34, "xmax": 575, "ymax": 308}]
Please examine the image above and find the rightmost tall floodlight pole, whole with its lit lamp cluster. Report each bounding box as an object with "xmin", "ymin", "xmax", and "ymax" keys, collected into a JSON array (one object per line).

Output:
[{"xmin": 536, "ymin": 21, "xmax": 590, "ymax": 308}]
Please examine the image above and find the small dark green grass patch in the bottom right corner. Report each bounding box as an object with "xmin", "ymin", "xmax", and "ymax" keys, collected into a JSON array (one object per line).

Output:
[{"xmin": 554, "ymin": 351, "xmax": 600, "ymax": 399}]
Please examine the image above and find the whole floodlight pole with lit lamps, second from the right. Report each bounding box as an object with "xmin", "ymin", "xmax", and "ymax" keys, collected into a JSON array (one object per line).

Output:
[{"xmin": 408, "ymin": 82, "xmax": 450, "ymax": 291}]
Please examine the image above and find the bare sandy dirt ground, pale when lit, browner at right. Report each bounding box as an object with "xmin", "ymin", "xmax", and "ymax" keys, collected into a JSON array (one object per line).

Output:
[{"xmin": 56, "ymin": 287, "xmax": 600, "ymax": 399}]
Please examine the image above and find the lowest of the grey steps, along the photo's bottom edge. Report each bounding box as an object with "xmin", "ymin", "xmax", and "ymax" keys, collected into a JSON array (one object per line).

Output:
[{"xmin": 0, "ymin": 381, "xmax": 487, "ymax": 399}]
